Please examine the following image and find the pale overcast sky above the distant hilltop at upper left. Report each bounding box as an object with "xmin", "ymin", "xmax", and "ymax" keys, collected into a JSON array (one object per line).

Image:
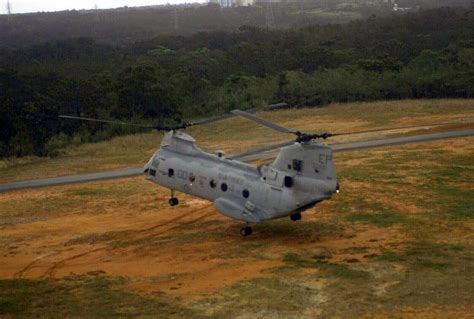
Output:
[{"xmin": 0, "ymin": 0, "xmax": 206, "ymax": 13}]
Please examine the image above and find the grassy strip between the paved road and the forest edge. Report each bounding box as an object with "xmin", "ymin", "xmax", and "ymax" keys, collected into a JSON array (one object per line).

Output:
[{"xmin": 0, "ymin": 100, "xmax": 474, "ymax": 183}]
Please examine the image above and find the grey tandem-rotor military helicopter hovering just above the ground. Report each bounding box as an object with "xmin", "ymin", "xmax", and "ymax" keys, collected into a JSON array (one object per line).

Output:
[{"xmin": 59, "ymin": 103, "xmax": 462, "ymax": 236}]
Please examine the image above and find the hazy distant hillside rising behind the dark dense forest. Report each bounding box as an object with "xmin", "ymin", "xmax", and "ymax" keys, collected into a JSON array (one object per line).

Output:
[{"xmin": 0, "ymin": 0, "xmax": 470, "ymax": 48}]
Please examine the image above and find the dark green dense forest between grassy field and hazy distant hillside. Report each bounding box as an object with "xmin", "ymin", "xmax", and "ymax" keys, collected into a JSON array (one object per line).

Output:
[{"xmin": 0, "ymin": 8, "xmax": 474, "ymax": 157}]
